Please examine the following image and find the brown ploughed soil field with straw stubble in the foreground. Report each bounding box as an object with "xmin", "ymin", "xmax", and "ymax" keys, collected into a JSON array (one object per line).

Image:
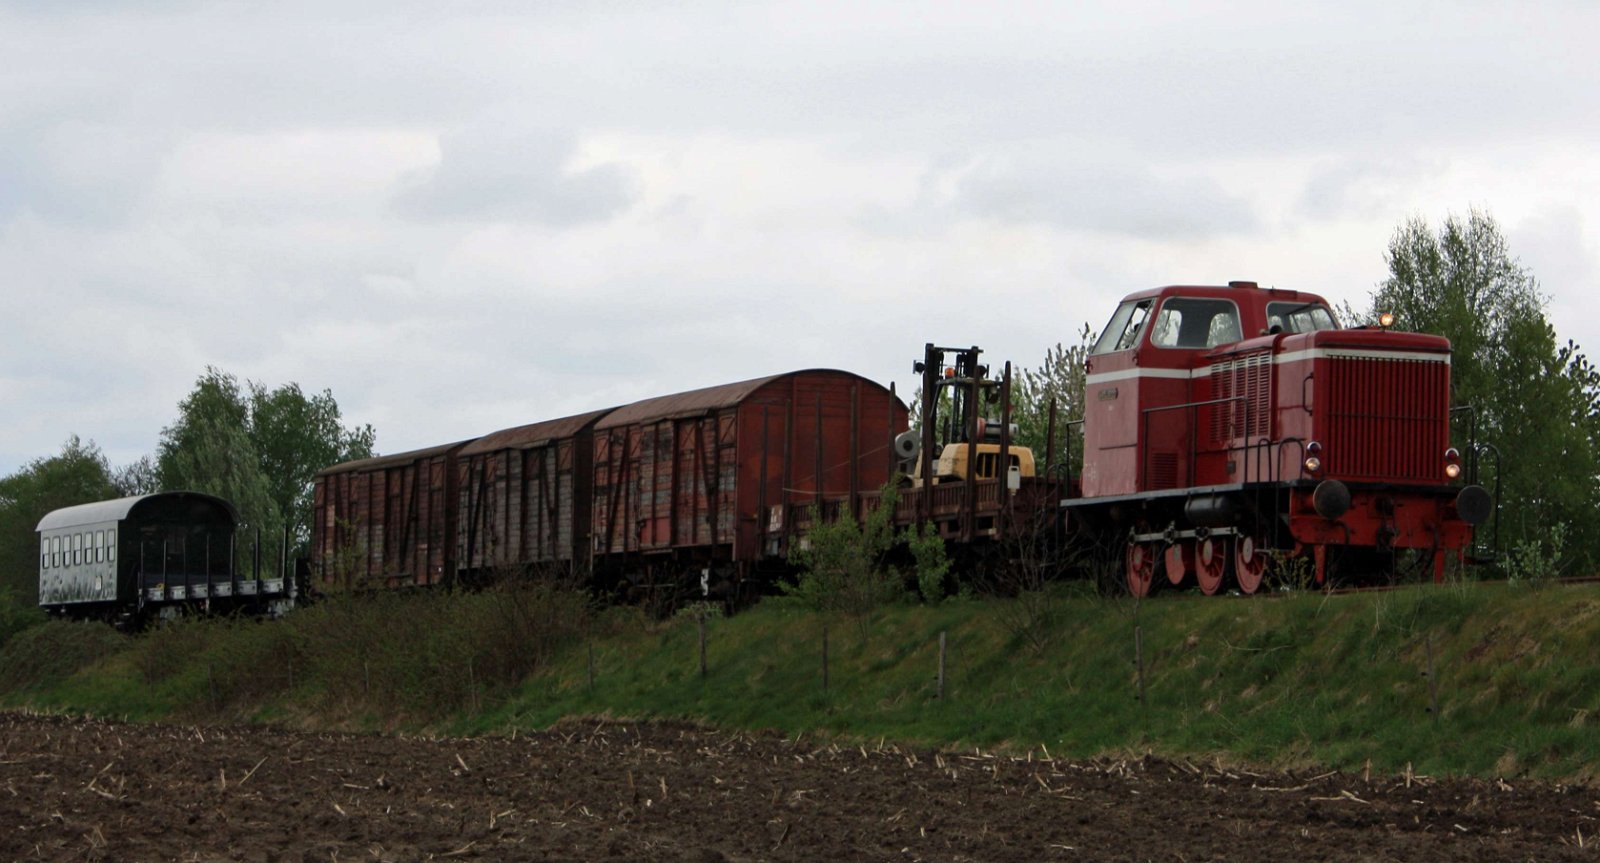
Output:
[{"xmin": 0, "ymin": 714, "xmax": 1600, "ymax": 863}]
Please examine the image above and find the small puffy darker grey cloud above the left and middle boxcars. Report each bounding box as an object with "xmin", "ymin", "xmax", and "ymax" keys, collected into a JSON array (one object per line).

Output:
[{"xmin": 392, "ymin": 123, "xmax": 638, "ymax": 227}]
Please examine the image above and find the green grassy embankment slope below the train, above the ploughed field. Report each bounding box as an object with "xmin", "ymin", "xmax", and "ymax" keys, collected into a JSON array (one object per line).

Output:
[{"xmin": 0, "ymin": 584, "xmax": 1600, "ymax": 781}]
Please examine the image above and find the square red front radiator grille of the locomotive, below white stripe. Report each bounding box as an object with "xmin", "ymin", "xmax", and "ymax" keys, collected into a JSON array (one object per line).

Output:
[{"xmin": 1326, "ymin": 357, "xmax": 1450, "ymax": 480}]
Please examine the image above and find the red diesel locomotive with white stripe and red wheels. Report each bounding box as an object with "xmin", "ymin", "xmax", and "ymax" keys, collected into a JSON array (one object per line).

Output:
[{"xmin": 1062, "ymin": 282, "xmax": 1493, "ymax": 596}]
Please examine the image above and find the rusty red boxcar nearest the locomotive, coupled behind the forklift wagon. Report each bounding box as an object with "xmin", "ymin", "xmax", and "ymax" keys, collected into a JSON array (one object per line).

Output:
[{"xmin": 592, "ymin": 368, "xmax": 907, "ymax": 586}]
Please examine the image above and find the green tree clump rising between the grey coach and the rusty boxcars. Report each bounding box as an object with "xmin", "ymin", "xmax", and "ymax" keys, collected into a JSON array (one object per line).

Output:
[{"xmin": 155, "ymin": 367, "xmax": 374, "ymax": 557}]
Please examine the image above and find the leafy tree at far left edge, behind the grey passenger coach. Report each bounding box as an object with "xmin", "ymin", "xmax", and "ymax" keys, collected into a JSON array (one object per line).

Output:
[{"xmin": 0, "ymin": 436, "xmax": 118, "ymax": 605}]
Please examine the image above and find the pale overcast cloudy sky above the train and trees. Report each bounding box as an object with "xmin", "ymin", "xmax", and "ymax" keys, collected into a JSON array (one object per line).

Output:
[{"xmin": 0, "ymin": 0, "xmax": 1600, "ymax": 476}]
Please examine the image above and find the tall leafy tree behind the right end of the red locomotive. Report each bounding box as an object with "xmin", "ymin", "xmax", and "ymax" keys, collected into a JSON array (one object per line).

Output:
[{"xmin": 1366, "ymin": 210, "xmax": 1600, "ymax": 573}]
